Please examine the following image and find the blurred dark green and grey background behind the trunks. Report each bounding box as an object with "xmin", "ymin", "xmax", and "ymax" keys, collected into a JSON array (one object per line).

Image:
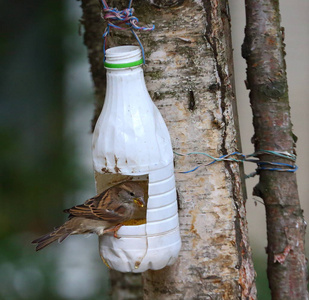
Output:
[{"xmin": 0, "ymin": 0, "xmax": 309, "ymax": 300}]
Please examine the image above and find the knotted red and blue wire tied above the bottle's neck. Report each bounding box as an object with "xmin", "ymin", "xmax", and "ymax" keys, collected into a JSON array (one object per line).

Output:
[{"xmin": 101, "ymin": 0, "xmax": 155, "ymax": 63}]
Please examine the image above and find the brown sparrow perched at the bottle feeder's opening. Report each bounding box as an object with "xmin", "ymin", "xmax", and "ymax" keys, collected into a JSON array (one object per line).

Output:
[{"xmin": 32, "ymin": 181, "xmax": 145, "ymax": 251}]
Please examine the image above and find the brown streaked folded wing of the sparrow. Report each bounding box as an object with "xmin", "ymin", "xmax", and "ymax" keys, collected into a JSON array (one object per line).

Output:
[{"xmin": 64, "ymin": 191, "xmax": 127, "ymax": 223}]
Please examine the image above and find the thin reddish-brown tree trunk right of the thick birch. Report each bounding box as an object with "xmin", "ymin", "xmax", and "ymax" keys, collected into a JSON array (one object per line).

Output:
[{"xmin": 243, "ymin": 0, "xmax": 308, "ymax": 300}]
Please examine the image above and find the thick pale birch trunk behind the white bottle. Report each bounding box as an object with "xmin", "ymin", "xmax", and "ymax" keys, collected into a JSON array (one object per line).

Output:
[{"xmin": 82, "ymin": 0, "xmax": 256, "ymax": 300}]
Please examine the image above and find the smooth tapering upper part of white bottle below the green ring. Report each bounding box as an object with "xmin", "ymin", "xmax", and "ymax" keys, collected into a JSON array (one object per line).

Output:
[{"xmin": 93, "ymin": 66, "xmax": 173, "ymax": 174}]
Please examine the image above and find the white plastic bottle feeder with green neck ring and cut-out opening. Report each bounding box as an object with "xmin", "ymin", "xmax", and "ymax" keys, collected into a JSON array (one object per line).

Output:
[{"xmin": 93, "ymin": 46, "xmax": 181, "ymax": 272}]
